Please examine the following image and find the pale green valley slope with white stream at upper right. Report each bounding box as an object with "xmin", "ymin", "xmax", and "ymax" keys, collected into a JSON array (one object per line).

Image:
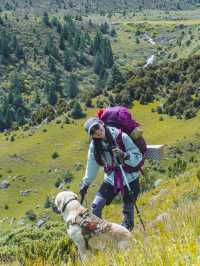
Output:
[{"xmin": 108, "ymin": 9, "xmax": 200, "ymax": 69}]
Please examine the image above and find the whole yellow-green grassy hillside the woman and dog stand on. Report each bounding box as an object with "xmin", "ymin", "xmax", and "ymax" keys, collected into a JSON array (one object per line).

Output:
[{"xmin": 0, "ymin": 104, "xmax": 200, "ymax": 266}]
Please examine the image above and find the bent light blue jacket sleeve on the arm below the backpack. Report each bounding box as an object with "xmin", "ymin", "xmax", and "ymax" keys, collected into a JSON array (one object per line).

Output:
[{"xmin": 122, "ymin": 133, "xmax": 142, "ymax": 167}]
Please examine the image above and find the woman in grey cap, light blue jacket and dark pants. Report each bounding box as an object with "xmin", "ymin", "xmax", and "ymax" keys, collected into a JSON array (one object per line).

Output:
[{"xmin": 80, "ymin": 117, "xmax": 143, "ymax": 231}]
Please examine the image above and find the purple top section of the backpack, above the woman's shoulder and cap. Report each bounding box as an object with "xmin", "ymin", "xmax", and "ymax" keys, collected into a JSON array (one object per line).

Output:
[{"xmin": 97, "ymin": 106, "xmax": 140, "ymax": 134}]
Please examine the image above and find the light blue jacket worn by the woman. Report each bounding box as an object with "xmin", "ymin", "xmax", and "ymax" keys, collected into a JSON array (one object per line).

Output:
[{"xmin": 82, "ymin": 127, "xmax": 142, "ymax": 186}]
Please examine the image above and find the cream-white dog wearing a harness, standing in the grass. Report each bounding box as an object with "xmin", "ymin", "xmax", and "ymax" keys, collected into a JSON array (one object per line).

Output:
[{"xmin": 55, "ymin": 191, "xmax": 131, "ymax": 261}]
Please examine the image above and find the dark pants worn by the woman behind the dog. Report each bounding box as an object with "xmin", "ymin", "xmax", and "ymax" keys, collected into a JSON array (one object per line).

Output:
[{"xmin": 92, "ymin": 178, "xmax": 140, "ymax": 231}]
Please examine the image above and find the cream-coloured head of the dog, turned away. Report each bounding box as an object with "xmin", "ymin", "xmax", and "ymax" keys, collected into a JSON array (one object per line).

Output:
[{"xmin": 55, "ymin": 190, "xmax": 78, "ymax": 213}]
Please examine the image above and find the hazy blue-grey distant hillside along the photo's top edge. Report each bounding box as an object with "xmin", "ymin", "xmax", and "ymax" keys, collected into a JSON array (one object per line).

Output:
[{"xmin": 1, "ymin": 0, "xmax": 199, "ymax": 13}]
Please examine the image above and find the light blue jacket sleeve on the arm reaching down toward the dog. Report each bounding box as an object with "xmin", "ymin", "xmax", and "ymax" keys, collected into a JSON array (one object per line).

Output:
[{"xmin": 82, "ymin": 142, "xmax": 100, "ymax": 186}]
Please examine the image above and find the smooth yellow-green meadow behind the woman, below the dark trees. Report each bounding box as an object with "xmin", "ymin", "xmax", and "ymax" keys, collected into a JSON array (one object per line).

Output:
[{"xmin": 0, "ymin": 101, "xmax": 200, "ymax": 232}]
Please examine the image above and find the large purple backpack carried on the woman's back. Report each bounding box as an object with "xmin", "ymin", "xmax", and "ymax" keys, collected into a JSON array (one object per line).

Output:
[{"xmin": 97, "ymin": 106, "xmax": 147, "ymax": 158}]
